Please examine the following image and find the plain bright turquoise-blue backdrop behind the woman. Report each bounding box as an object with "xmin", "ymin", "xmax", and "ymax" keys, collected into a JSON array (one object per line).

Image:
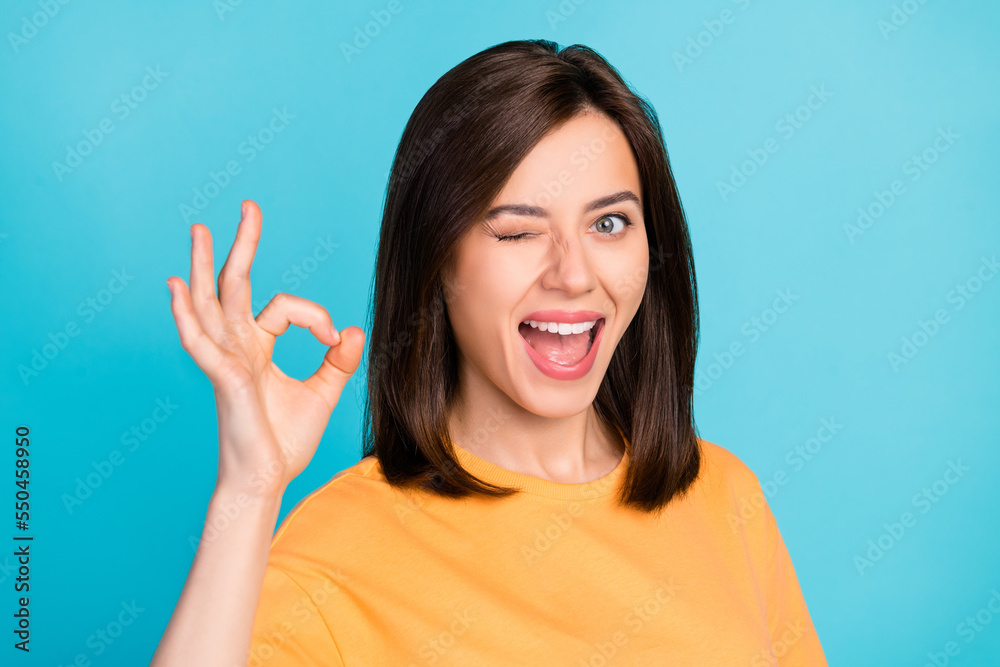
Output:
[{"xmin": 0, "ymin": 0, "xmax": 1000, "ymax": 665}]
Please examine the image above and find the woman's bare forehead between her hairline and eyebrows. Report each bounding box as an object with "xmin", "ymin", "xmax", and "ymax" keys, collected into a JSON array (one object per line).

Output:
[{"xmin": 494, "ymin": 112, "xmax": 641, "ymax": 208}]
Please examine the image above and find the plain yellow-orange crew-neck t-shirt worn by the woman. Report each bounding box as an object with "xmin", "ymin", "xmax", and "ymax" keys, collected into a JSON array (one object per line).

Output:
[{"xmin": 249, "ymin": 440, "xmax": 827, "ymax": 667}]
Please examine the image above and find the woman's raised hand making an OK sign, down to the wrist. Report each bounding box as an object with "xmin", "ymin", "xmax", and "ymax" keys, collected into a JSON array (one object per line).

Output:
[{"xmin": 167, "ymin": 200, "xmax": 365, "ymax": 496}]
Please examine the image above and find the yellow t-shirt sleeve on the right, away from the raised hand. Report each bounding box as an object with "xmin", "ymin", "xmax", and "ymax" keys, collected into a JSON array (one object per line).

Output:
[{"xmin": 763, "ymin": 501, "xmax": 827, "ymax": 667}]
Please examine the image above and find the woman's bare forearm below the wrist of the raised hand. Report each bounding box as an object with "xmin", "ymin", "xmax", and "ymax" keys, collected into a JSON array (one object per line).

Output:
[{"xmin": 150, "ymin": 485, "xmax": 281, "ymax": 667}]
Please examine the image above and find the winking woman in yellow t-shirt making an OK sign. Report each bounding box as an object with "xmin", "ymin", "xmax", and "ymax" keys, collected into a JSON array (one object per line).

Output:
[{"xmin": 153, "ymin": 40, "xmax": 826, "ymax": 667}]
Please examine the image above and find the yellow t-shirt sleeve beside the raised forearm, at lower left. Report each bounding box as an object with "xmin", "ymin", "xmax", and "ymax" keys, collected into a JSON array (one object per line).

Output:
[{"xmin": 247, "ymin": 563, "xmax": 344, "ymax": 667}]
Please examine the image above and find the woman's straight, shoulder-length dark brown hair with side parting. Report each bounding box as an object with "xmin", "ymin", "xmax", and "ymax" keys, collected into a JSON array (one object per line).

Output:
[{"xmin": 363, "ymin": 40, "xmax": 701, "ymax": 512}]
